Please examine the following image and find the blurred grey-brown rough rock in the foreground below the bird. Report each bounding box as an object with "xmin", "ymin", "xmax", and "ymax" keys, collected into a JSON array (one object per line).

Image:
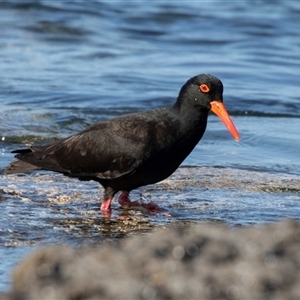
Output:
[{"xmin": 5, "ymin": 221, "xmax": 300, "ymax": 300}]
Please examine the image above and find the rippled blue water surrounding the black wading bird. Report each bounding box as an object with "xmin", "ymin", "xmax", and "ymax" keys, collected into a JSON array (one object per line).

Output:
[{"xmin": 0, "ymin": 0, "xmax": 300, "ymax": 290}]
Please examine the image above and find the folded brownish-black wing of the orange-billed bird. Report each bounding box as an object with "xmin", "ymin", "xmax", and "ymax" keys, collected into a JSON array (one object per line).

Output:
[{"xmin": 16, "ymin": 115, "xmax": 172, "ymax": 179}]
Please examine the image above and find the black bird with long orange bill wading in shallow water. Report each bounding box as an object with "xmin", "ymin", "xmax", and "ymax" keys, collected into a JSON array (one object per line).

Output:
[{"xmin": 5, "ymin": 74, "xmax": 240, "ymax": 213}]
